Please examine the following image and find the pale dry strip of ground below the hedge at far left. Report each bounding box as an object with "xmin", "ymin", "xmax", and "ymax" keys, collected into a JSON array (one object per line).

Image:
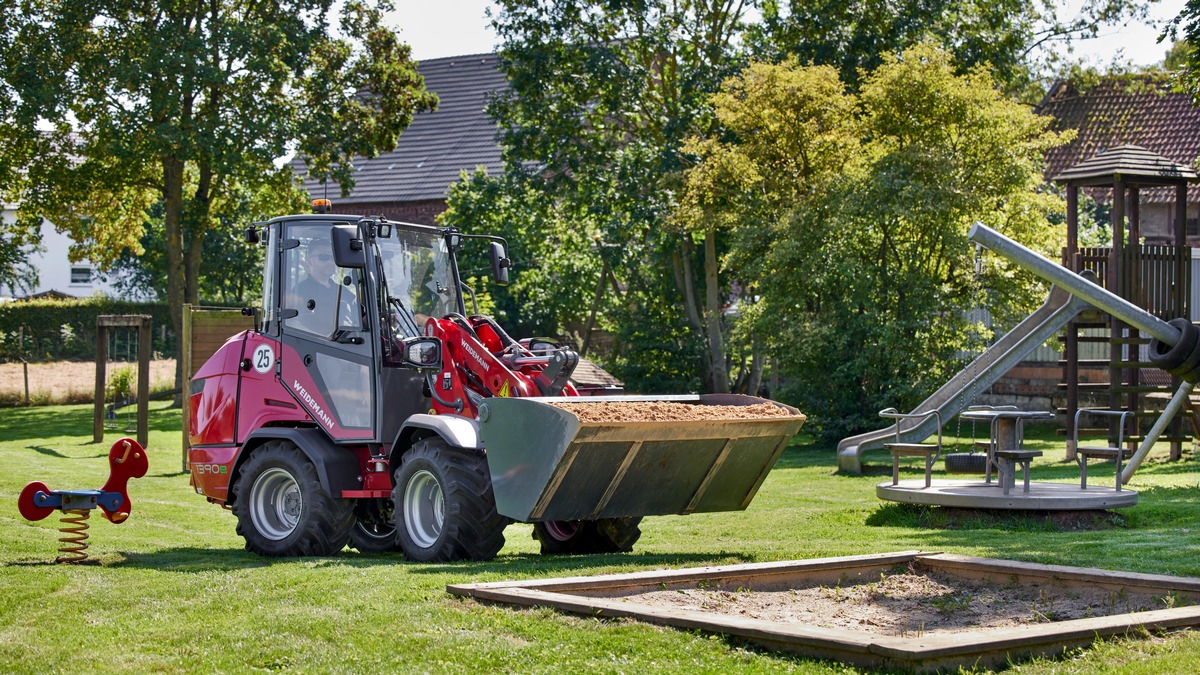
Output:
[{"xmin": 0, "ymin": 359, "xmax": 175, "ymax": 405}]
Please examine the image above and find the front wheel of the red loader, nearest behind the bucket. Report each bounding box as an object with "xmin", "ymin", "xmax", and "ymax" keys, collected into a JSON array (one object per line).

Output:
[{"xmin": 391, "ymin": 437, "xmax": 508, "ymax": 562}]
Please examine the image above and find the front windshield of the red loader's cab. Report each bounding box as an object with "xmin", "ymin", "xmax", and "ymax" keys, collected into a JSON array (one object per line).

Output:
[{"xmin": 376, "ymin": 228, "xmax": 460, "ymax": 338}]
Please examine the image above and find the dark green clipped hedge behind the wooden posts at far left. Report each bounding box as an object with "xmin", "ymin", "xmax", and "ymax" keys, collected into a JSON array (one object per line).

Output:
[{"xmin": 0, "ymin": 297, "xmax": 175, "ymax": 363}]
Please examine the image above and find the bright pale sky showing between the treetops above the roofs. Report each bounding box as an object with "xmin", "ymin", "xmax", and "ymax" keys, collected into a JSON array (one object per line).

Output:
[{"xmin": 389, "ymin": 0, "xmax": 1184, "ymax": 66}]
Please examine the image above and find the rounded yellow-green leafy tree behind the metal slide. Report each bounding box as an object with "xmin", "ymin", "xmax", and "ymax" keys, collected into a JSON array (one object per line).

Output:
[{"xmin": 680, "ymin": 44, "xmax": 1063, "ymax": 438}]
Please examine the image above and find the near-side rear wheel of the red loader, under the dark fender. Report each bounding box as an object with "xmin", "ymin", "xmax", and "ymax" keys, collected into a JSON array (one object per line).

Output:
[{"xmin": 233, "ymin": 441, "xmax": 354, "ymax": 557}]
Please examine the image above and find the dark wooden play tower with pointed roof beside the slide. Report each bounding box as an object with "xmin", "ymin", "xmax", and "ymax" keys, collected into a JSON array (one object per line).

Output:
[{"xmin": 1054, "ymin": 145, "xmax": 1200, "ymax": 459}]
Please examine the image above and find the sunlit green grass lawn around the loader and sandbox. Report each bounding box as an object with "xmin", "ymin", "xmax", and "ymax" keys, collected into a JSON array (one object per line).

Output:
[{"xmin": 0, "ymin": 404, "xmax": 1200, "ymax": 674}]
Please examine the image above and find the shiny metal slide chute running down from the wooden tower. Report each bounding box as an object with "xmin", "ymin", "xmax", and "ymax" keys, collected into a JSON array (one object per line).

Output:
[{"xmin": 838, "ymin": 286, "xmax": 1090, "ymax": 473}]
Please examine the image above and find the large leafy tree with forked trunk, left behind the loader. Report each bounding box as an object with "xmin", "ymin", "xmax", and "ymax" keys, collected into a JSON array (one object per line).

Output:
[{"xmin": 0, "ymin": 0, "xmax": 436, "ymax": 379}]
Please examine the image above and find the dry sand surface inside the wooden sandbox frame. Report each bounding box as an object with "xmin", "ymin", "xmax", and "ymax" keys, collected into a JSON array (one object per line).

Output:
[{"xmin": 589, "ymin": 565, "xmax": 1184, "ymax": 635}]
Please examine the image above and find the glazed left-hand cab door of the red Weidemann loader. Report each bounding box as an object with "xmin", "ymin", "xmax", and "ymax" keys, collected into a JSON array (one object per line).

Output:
[{"xmin": 278, "ymin": 220, "xmax": 379, "ymax": 442}]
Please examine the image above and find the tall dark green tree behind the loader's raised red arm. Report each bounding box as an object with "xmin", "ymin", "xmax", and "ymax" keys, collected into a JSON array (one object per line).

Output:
[{"xmin": 458, "ymin": 0, "xmax": 748, "ymax": 390}]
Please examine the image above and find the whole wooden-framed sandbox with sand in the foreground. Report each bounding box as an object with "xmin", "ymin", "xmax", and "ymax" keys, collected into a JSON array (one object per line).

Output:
[{"xmin": 446, "ymin": 551, "xmax": 1200, "ymax": 671}]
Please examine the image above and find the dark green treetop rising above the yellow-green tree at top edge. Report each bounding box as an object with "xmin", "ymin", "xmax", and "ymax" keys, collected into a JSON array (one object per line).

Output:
[{"xmin": 751, "ymin": 0, "xmax": 1148, "ymax": 102}]
